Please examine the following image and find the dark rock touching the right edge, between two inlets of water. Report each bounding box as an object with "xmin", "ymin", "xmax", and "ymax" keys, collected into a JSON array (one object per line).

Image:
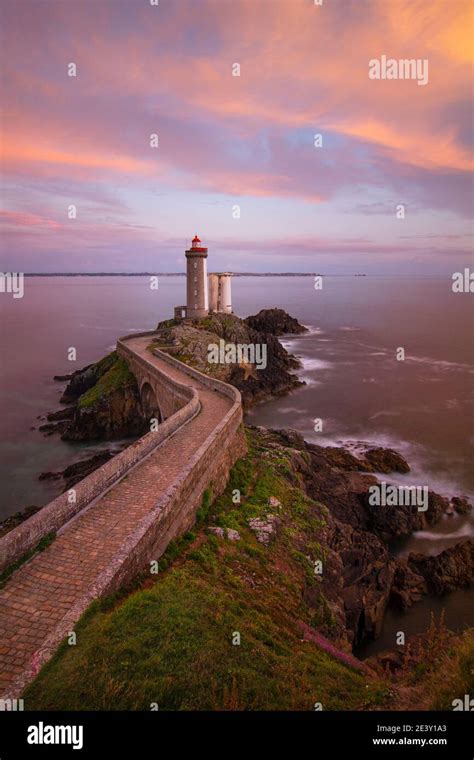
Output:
[{"xmin": 408, "ymin": 539, "xmax": 474, "ymax": 595}]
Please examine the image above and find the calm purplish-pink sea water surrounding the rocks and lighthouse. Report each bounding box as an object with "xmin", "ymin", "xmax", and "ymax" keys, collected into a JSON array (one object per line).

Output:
[{"xmin": 0, "ymin": 277, "xmax": 474, "ymax": 651}]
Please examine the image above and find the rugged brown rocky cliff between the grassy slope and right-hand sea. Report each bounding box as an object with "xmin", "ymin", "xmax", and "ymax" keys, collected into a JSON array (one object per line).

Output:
[{"xmin": 246, "ymin": 428, "xmax": 473, "ymax": 647}]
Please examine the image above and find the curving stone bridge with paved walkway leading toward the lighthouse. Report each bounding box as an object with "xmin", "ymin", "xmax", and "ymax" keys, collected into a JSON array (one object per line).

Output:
[{"xmin": 0, "ymin": 333, "xmax": 246, "ymax": 707}]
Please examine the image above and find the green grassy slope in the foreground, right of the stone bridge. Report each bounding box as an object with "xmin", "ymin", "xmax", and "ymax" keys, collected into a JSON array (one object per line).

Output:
[{"xmin": 24, "ymin": 432, "xmax": 474, "ymax": 710}]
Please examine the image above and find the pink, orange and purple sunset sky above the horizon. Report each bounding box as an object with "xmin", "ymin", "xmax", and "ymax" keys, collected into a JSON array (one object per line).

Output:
[{"xmin": 0, "ymin": 0, "xmax": 474, "ymax": 276}]
